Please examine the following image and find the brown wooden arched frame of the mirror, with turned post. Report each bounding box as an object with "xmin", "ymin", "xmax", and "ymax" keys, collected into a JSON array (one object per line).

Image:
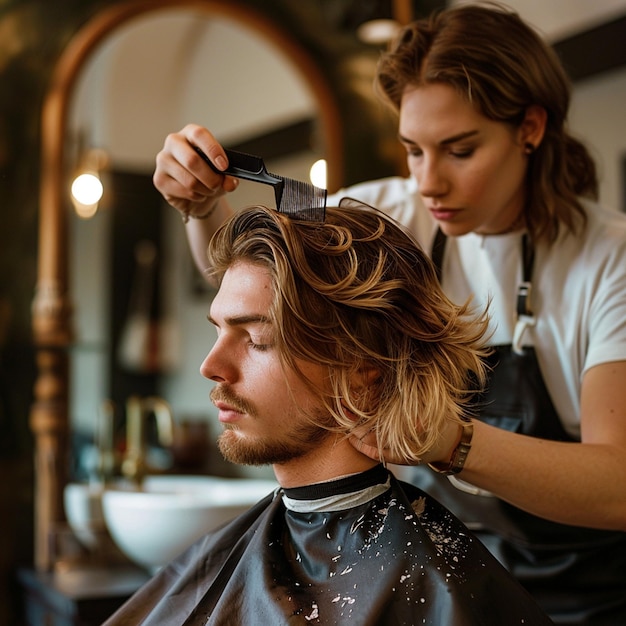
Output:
[{"xmin": 30, "ymin": 0, "xmax": 343, "ymax": 571}]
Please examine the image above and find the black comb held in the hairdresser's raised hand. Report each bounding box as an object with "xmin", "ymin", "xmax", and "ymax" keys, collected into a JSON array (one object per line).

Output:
[{"xmin": 196, "ymin": 147, "xmax": 327, "ymax": 222}]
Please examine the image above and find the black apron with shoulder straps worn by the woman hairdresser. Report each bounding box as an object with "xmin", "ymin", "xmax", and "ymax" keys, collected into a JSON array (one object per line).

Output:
[{"xmin": 412, "ymin": 231, "xmax": 626, "ymax": 626}]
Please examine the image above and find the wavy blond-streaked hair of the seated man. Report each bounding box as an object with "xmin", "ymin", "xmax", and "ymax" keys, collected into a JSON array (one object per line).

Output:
[{"xmin": 208, "ymin": 204, "xmax": 487, "ymax": 461}]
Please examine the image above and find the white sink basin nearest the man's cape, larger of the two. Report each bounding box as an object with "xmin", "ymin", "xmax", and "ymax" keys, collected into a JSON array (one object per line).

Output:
[{"xmin": 102, "ymin": 476, "xmax": 278, "ymax": 571}]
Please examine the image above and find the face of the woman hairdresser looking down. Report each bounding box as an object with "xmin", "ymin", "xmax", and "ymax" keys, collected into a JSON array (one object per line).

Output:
[{"xmin": 399, "ymin": 84, "xmax": 528, "ymax": 236}]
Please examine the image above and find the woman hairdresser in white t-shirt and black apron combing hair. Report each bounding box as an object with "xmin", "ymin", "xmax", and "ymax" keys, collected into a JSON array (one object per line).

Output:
[{"xmin": 154, "ymin": 5, "xmax": 626, "ymax": 626}]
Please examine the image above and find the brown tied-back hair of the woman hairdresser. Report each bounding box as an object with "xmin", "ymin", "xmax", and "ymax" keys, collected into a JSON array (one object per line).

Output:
[{"xmin": 377, "ymin": 4, "xmax": 598, "ymax": 241}]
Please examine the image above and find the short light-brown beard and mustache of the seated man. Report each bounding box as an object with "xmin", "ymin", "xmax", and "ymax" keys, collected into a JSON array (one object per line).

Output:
[{"xmin": 211, "ymin": 387, "xmax": 337, "ymax": 465}]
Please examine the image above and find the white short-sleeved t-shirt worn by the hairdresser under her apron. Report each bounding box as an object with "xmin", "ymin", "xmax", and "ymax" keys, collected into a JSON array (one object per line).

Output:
[{"xmin": 328, "ymin": 177, "xmax": 626, "ymax": 438}]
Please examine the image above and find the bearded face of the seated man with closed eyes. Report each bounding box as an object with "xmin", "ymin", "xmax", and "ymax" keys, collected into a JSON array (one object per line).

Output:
[{"xmin": 200, "ymin": 262, "xmax": 330, "ymax": 465}]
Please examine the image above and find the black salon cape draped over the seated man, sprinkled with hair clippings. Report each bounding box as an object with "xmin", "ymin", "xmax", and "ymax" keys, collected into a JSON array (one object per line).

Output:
[{"xmin": 105, "ymin": 466, "xmax": 552, "ymax": 626}]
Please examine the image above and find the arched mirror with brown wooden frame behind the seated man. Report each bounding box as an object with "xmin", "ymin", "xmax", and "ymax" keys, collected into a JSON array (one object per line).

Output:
[{"xmin": 31, "ymin": 0, "xmax": 342, "ymax": 569}]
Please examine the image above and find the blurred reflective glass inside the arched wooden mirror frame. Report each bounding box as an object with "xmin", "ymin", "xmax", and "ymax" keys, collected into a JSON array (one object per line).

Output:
[{"xmin": 68, "ymin": 9, "xmax": 324, "ymax": 477}]
